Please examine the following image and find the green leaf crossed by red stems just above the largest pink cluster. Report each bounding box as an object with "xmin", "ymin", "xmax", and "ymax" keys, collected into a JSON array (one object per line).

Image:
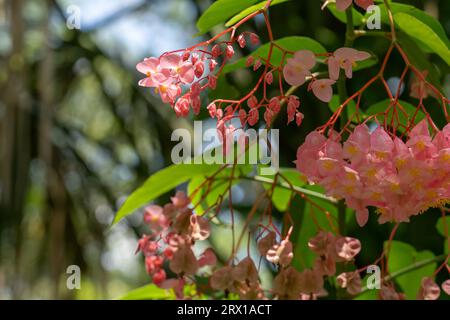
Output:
[{"xmin": 365, "ymin": 99, "xmax": 425, "ymax": 132}]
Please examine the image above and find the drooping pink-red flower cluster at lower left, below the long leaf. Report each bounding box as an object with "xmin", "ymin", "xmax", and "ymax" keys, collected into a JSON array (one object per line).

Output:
[{"xmin": 137, "ymin": 192, "xmax": 216, "ymax": 297}]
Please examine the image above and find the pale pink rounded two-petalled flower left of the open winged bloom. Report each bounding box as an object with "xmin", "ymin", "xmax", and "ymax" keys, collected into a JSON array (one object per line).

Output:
[{"xmin": 283, "ymin": 50, "xmax": 316, "ymax": 86}]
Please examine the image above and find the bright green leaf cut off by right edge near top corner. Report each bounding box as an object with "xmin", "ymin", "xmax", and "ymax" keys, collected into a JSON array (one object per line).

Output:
[{"xmin": 394, "ymin": 13, "xmax": 450, "ymax": 66}]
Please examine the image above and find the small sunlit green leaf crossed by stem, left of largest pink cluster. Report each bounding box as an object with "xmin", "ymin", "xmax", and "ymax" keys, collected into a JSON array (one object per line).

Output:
[{"xmin": 262, "ymin": 168, "xmax": 306, "ymax": 212}]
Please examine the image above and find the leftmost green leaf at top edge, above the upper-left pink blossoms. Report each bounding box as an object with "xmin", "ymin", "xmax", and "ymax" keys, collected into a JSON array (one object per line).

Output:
[{"xmin": 197, "ymin": 0, "xmax": 259, "ymax": 35}]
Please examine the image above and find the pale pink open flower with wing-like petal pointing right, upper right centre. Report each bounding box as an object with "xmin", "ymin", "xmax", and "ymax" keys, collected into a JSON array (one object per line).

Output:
[{"xmin": 328, "ymin": 47, "xmax": 370, "ymax": 80}]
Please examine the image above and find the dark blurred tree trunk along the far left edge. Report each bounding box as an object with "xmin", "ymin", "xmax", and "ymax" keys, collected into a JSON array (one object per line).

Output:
[{"xmin": 0, "ymin": 0, "xmax": 31, "ymax": 297}]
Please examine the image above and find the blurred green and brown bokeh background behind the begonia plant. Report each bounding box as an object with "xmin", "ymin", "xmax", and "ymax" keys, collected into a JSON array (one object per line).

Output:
[{"xmin": 0, "ymin": 0, "xmax": 450, "ymax": 299}]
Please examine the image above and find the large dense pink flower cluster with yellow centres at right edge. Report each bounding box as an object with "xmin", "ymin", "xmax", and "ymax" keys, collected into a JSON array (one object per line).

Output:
[{"xmin": 296, "ymin": 119, "xmax": 450, "ymax": 226}]
